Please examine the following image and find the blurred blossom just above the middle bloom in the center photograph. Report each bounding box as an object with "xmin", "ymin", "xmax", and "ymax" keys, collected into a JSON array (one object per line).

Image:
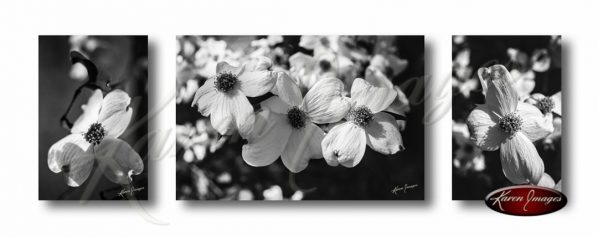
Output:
[{"xmin": 289, "ymin": 53, "xmax": 353, "ymax": 90}]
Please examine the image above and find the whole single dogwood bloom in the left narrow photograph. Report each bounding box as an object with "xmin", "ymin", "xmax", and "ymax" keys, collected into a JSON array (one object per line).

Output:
[{"xmin": 48, "ymin": 89, "xmax": 143, "ymax": 187}]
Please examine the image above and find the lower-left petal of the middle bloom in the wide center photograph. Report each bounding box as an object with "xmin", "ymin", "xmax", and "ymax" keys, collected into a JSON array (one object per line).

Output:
[{"xmin": 242, "ymin": 110, "xmax": 292, "ymax": 167}]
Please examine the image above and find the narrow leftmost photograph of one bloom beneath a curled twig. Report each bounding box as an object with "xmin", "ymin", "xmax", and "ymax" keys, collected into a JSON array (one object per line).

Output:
[{"xmin": 38, "ymin": 35, "xmax": 148, "ymax": 201}]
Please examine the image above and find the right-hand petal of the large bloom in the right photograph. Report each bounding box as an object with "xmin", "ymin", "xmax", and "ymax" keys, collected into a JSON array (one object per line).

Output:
[{"xmin": 517, "ymin": 102, "xmax": 554, "ymax": 142}]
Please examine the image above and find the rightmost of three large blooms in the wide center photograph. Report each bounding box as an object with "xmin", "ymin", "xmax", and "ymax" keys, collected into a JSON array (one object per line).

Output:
[{"xmin": 322, "ymin": 78, "xmax": 404, "ymax": 167}]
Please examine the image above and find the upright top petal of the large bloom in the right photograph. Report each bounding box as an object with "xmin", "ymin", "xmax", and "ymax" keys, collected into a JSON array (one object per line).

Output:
[{"xmin": 479, "ymin": 64, "xmax": 519, "ymax": 115}]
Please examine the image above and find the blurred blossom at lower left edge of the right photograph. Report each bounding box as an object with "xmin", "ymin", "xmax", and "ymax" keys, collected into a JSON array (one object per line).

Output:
[{"xmin": 453, "ymin": 121, "xmax": 486, "ymax": 172}]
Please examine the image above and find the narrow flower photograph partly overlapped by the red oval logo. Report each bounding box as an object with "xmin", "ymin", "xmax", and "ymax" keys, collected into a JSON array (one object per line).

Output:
[{"xmin": 452, "ymin": 35, "xmax": 563, "ymax": 200}]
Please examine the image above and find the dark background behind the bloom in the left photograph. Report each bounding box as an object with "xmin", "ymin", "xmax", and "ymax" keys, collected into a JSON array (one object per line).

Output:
[{"xmin": 38, "ymin": 36, "xmax": 148, "ymax": 200}]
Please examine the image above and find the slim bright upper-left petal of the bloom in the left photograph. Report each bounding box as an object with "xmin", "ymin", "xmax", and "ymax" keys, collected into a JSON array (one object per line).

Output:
[{"xmin": 71, "ymin": 89, "xmax": 104, "ymax": 133}]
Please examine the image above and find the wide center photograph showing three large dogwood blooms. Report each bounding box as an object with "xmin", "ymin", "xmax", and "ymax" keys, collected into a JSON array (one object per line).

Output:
[{"xmin": 176, "ymin": 35, "xmax": 425, "ymax": 200}]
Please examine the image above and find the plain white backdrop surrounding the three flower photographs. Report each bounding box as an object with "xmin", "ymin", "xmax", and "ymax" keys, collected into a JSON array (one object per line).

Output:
[{"xmin": 0, "ymin": 0, "xmax": 598, "ymax": 236}]
